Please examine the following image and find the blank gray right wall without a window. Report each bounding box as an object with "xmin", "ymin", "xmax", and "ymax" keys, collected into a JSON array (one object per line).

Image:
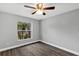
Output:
[{"xmin": 41, "ymin": 9, "xmax": 79, "ymax": 53}]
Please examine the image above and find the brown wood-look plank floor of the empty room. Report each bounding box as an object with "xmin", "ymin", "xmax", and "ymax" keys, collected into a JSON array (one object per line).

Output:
[{"xmin": 0, "ymin": 42, "xmax": 76, "ymax": 56}]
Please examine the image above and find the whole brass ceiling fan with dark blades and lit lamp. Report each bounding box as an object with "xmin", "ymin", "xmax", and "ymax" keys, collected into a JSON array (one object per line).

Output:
[{"xmin": 24, "ymin": 3, "xmax": 55, "ymax": 15}]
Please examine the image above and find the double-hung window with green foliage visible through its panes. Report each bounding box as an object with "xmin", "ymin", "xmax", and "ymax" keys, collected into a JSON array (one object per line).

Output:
[{"xmin": 17, "ymin": 22, "xmax": 31, "ymax": 40}]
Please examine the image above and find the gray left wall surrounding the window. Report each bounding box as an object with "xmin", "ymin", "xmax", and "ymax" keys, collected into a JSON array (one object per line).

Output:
[{"xmin": 0, "ymin": 12, "xmax": 39, "ymax": 49}]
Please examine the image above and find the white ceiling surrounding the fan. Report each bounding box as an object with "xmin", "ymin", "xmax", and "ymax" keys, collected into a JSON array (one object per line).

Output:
[{"xmin": 0, "ymin": 3, "xmax": 79, "ymax": 20}]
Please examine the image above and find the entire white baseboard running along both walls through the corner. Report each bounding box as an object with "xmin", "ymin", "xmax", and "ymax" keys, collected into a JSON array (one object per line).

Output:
[{"xmin": 0, "ymin": 40, "xmax": 79, "ymax": 55}]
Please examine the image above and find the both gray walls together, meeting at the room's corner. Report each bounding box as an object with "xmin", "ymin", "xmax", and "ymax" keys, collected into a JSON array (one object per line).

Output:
[{"xmin": 0, "ymin": 7, "xmax": 79, "ymax": 53}]
